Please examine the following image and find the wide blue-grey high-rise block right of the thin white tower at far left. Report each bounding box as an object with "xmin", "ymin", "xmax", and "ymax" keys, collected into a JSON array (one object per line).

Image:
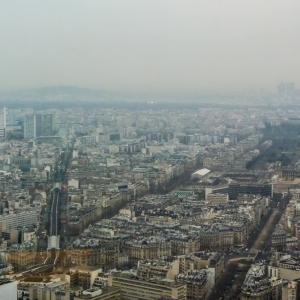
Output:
[{"xmin": 24, "ymin": 114, "xmax": 53, "ymax": 139}]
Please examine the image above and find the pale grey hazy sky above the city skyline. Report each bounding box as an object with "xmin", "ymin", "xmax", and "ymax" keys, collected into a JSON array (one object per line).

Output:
[{"xmin": 0, "ymin": 0, "xmax": 300, "ymax": 92}]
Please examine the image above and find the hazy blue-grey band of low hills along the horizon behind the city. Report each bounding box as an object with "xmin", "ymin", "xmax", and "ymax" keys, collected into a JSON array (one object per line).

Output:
[{"xmin": 0, "ymin": 86, "xmax": 290, "ymax": 110}]
